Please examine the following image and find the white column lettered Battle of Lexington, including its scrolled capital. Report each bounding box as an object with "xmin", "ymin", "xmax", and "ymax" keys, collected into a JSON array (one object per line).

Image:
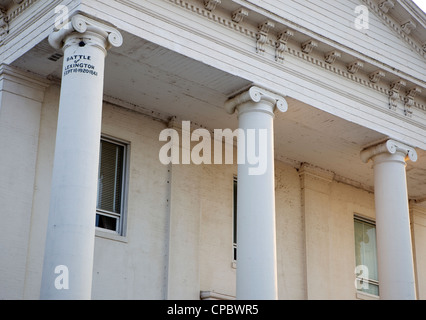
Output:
[{"xmin": 40, "ymin": 15, "xmax": 122, "ymax": 299}]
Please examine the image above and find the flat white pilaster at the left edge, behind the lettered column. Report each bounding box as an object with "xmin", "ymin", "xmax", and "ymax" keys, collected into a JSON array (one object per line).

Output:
[{"xmin": 0, "ymin": 66, "xmax": 47, "ymax": 299}]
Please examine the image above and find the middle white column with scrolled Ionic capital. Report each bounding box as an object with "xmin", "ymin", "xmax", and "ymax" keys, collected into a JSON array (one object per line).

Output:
[{"xmin": 225, "ymin": 87, "xmax": 287, "ymax": 300}]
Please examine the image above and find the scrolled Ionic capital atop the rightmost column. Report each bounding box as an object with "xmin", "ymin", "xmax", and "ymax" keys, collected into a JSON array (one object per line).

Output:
[{"xmin": 360, "ymin": 140, "xmax": 417, "ymax": 163}]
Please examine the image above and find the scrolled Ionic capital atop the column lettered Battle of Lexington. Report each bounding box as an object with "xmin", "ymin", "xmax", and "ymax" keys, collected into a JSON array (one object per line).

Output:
[{"xmin": 49, "ymin": 14, "xmax": 123, "ymax": 50}]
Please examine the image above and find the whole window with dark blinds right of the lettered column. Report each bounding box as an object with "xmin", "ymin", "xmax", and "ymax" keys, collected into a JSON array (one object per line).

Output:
[{"xmin": 96, "ymin": 138, "xmax": 127, "ymax": 235}]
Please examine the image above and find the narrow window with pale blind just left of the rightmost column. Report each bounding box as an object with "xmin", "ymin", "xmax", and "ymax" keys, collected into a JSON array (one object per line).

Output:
[{"xmin": 354, "ymin": 217, "xmax": 379, "ymax": 296}]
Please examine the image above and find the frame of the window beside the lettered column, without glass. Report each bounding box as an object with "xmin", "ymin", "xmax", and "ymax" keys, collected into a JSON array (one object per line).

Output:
[{"xmin": 95, "ymin": 134, "xmax": 130, "ymax": 237}]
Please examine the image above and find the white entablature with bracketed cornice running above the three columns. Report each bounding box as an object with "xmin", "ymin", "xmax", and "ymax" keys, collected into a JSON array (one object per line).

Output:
[{"xmin": 0, "ymin": 0, "xmax": 426, "ymax": 149}]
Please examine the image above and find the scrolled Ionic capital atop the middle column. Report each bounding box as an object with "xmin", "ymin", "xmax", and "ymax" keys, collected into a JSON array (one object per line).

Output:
[{"xmin": 225, "ymin": 86, "xmax": 288, "ymax": 114}]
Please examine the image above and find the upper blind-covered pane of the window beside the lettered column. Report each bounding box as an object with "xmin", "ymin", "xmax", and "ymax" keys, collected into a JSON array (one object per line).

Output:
[{"xmin": 97, "ymin": 141, "xmax": 124, "ymax": 213}]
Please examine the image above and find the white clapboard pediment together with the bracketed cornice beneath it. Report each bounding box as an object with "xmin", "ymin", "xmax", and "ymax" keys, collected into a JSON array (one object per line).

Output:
[{"xmin": 212, "ymin": 0, "xmax": 426, "ymax": 112}]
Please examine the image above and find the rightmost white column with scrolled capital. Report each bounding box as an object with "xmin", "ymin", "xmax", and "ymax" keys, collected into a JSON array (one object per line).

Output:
[{"xmin": 361, "ymin": 140, "xmax": 417, "ymax": 300}]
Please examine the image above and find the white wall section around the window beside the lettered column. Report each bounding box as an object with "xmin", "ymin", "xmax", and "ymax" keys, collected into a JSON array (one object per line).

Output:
[{"xmin": 88, "ymin": 105, "xmax": 169, "ymax": 299}]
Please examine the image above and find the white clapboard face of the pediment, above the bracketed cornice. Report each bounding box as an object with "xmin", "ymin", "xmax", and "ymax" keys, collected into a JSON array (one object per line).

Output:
[{"xmin": 233, "ymin": 0, "xmax": 426, "ymax": 84}]
